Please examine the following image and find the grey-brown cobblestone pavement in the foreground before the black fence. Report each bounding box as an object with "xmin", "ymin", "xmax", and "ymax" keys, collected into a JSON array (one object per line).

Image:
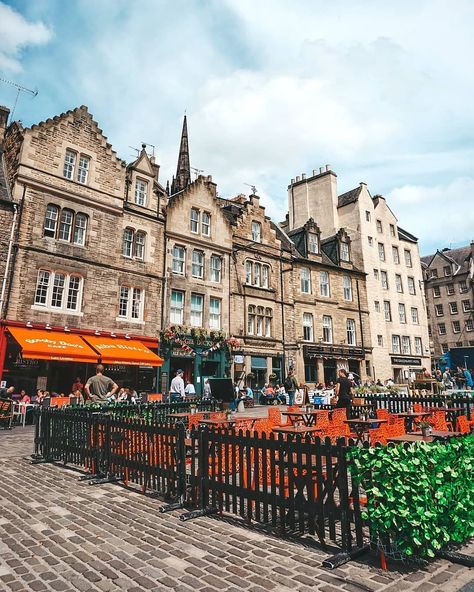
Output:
[{"xmin": 0, "ymin": 427, "xmax": 474, "ymax": 592}]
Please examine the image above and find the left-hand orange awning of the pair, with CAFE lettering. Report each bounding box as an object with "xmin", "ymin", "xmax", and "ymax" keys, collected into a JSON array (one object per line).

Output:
[{"xmin": 8, "ymin": 327, "xmax": 98, "ymax": 364}]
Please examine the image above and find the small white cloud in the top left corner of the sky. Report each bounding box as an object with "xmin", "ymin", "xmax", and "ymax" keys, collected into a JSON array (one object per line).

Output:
[{"xmin": 0, "ymin": 2, "xmax": 51, "ymax": 72}]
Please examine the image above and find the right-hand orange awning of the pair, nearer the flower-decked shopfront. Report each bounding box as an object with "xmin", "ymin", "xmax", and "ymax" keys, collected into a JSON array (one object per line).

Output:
[{"xmin": 82, "ymin": 335, "xmax": 163, "ymax": 366}]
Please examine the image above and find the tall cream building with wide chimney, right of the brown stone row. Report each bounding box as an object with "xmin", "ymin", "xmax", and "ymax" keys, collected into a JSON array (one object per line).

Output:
[{"xmin": 288, "ymin": 165, "xmax": 430, "ymax": 382}]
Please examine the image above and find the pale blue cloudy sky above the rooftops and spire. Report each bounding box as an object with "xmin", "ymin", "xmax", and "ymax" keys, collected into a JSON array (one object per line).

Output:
[{"xmin": 0, "ymin": 0, "xmax": 474, "ymax": 254}]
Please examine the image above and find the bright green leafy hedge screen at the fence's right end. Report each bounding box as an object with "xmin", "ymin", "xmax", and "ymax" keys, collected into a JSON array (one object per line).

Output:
[{"xmin": 348, "ymin": 434, "xmax": 474, "ymax": 557}]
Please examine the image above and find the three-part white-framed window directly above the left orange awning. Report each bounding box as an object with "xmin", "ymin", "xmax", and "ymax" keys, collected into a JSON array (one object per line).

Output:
[{"xmin": 34, "ymin": 269, "xmax": 83, "ymax": 313}]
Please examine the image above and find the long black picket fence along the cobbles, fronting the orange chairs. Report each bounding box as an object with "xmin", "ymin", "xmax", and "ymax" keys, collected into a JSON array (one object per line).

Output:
[{"xmin": 35, "ymin": 409, "xmax": 364, "ymax": 553}]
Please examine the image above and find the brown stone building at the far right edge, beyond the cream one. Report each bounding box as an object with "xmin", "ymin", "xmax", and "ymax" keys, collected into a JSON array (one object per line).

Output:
[{"xmin": 421, "ymin": 246, "xmax": 474, "ymax": 360}]
